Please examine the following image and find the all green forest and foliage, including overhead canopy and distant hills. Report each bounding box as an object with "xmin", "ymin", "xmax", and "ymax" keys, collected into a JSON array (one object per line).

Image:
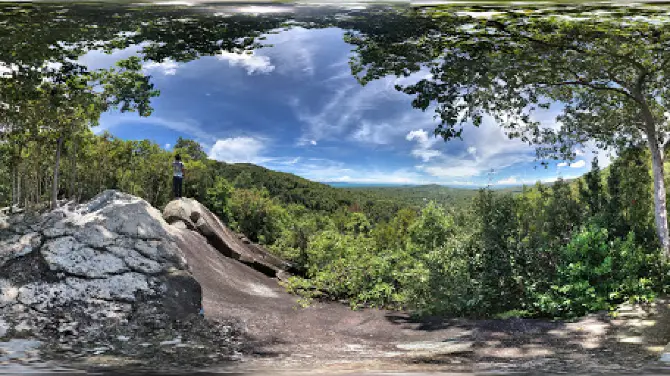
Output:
[{"xmin": 0, "ymin": 5, "xmax": 670, "ymax": 318}]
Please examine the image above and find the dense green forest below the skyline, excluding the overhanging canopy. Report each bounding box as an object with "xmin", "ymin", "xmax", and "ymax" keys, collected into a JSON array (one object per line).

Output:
[{"xmin": 0, "ymin": 132, "xmax": 667, "ymax": 317}]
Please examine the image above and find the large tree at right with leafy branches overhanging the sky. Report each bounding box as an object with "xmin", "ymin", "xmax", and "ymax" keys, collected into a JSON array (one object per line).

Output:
[{"xmin": 347, "ymin": 7, "xmax": 670, "ymax": 258}]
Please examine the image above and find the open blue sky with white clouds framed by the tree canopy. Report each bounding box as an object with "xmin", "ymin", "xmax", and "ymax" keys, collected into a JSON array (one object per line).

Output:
[{"xmin": 83, "ymin": 28, "xmax": 609, "ymax": 186}]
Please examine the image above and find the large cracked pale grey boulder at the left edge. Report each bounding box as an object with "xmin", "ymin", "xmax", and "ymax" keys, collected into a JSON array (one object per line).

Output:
[{"xmin": 0, "ymin": 190, "xmax": 202, "ymax": 335}]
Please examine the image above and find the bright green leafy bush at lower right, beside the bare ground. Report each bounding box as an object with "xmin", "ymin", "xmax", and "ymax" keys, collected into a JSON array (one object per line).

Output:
[{"xmin": 535, "ymin": 225, "xmax": 662, "ymax": 317}]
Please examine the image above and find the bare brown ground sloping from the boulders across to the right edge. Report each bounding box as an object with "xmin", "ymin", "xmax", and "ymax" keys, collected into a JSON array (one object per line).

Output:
[{"xmin": 180, "ymin": 234, "xmax": 670, "ymax": 374}]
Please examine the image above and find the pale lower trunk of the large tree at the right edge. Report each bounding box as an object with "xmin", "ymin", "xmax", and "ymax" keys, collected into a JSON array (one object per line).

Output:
[{"xmin": 647, "ymin": 138, "xmax": 670, "ymax": 260}]
